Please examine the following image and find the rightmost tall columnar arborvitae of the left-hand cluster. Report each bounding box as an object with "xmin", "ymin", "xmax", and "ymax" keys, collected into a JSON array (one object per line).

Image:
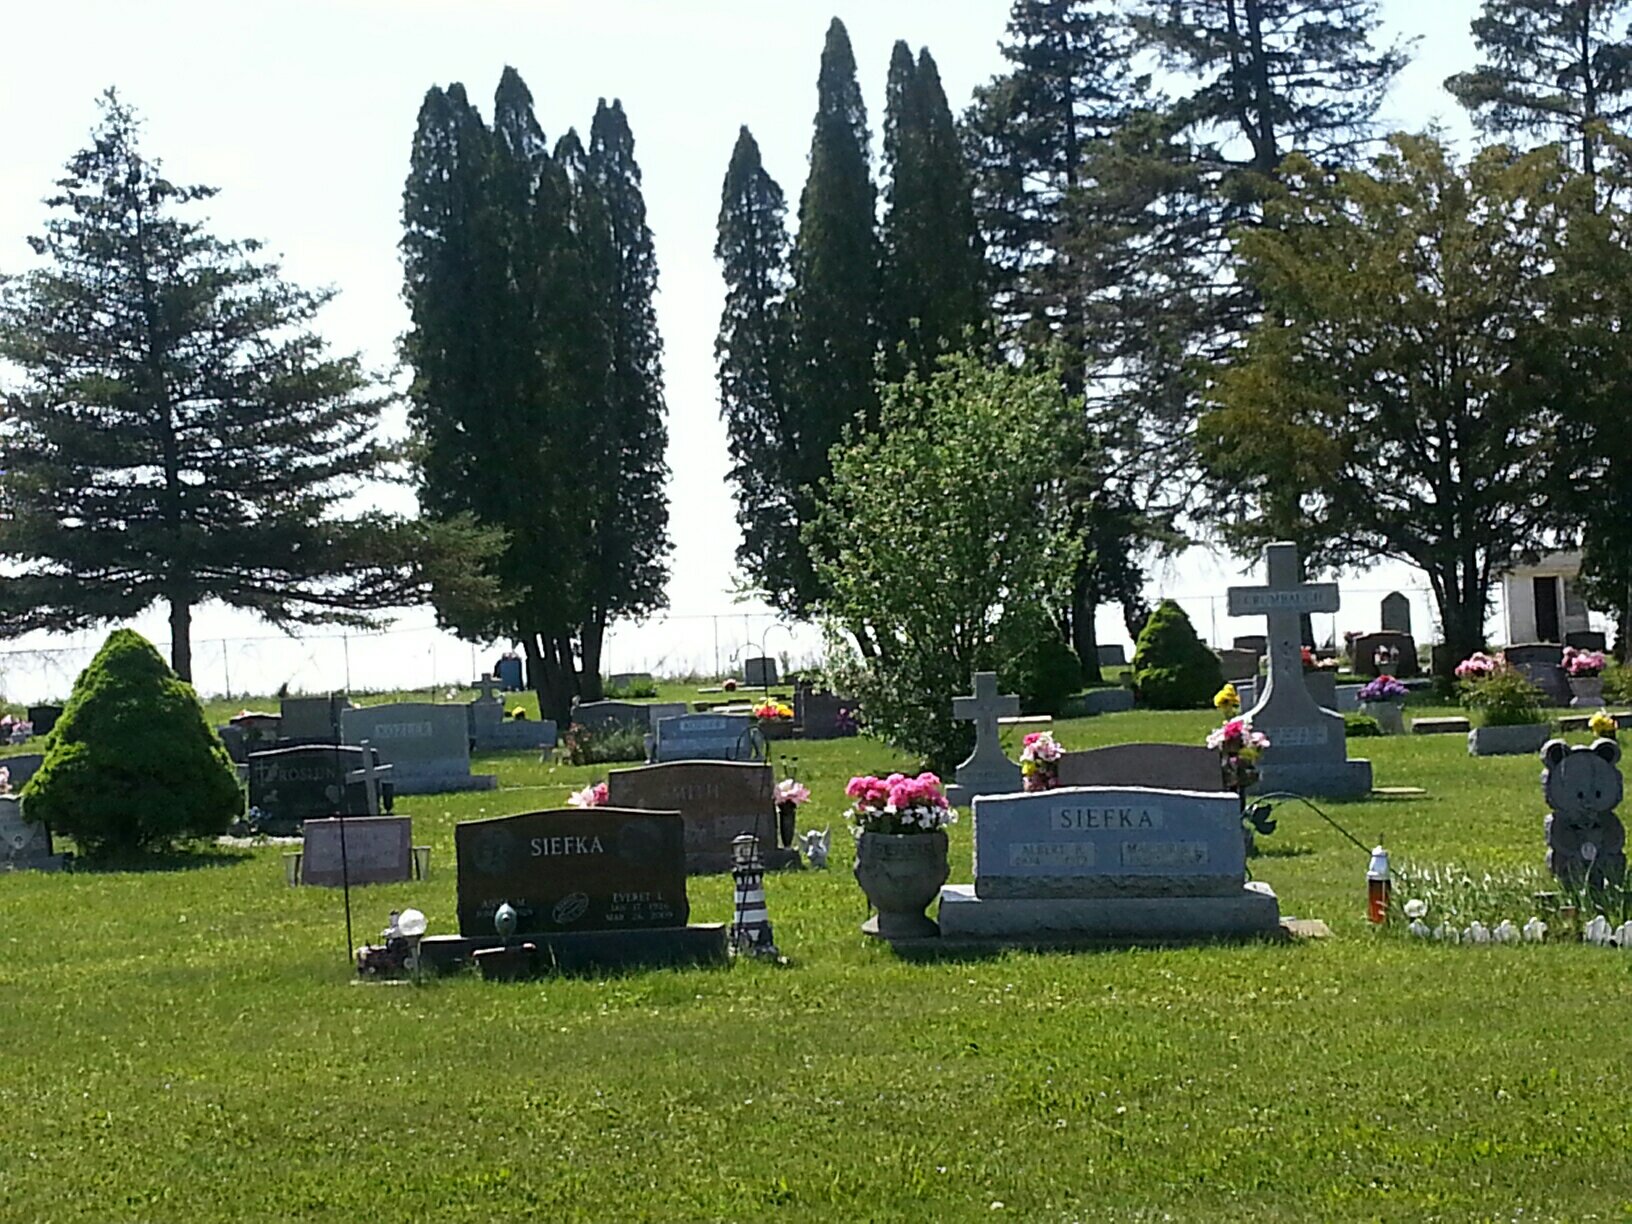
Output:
[{"xmin": 579, "ymin": 100, "xmax": 669, "ymax": 700}]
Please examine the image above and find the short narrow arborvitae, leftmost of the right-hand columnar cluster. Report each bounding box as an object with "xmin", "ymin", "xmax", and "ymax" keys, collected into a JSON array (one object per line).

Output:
[{"xmin": 715, "ymin": 127, "xmax": 798, "ymax": 591}]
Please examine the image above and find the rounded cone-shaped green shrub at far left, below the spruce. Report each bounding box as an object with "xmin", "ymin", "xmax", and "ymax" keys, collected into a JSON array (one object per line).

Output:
[{"xmin": 23, "ymin": 628, "xmax": 243, "ymax": 855}]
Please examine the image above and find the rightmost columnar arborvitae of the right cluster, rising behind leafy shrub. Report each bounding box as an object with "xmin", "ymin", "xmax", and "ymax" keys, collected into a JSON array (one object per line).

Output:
[{"xmin": 878, "ymin": 42, "xmax": 986, "ymax": 379}]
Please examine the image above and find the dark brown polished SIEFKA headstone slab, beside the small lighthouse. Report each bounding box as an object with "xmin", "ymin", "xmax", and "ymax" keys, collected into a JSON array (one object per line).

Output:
[{"xmin": 454, "ymin": 808, "xmax": 690, "ymax": 937}]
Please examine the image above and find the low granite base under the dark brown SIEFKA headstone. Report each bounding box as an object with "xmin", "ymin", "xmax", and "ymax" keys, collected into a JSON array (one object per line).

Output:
[{"xmin": 419, "ymin": 922, "xmax": 730, "ymax": 976}]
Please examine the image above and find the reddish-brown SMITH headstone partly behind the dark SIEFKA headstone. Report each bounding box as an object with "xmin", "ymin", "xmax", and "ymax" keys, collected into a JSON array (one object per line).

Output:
[{"xmin": 607, "ymin": 761, "xmax": 798, "ymax": 875}]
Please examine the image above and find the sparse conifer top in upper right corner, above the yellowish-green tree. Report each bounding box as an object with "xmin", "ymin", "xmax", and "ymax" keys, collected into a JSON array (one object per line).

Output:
[{"xmin": 1444, "ymin": 0, "xmax": 1632, "ymax": 178}]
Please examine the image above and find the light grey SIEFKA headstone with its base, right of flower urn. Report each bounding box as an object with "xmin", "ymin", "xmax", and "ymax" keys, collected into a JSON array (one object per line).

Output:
[{"xmin": 940, "ymin": 789, "xmax": 1296, "ymax": 943}]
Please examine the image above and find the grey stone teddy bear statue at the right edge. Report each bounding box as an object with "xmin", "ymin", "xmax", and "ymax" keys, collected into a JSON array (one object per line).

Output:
[{"xmin": 1541, "ymin": 739, "xmax": 1627, "ymax": 888}]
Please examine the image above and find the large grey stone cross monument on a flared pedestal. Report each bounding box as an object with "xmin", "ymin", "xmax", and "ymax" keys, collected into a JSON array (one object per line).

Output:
[{"xmin": 1229, "ymin": 543, "xmax": 1371, "ymax": 798}]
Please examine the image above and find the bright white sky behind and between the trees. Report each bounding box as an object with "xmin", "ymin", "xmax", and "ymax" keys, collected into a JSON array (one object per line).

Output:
[{"xmin": 0, "ymin": 0, "xmax": 1501, "ymax": 700}]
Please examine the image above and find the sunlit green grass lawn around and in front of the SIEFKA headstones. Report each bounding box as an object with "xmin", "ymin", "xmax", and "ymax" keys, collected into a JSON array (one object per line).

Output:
[{"xmin": 0, "ymin": 705, "xmax": 1632, "ymax": 1222}]
